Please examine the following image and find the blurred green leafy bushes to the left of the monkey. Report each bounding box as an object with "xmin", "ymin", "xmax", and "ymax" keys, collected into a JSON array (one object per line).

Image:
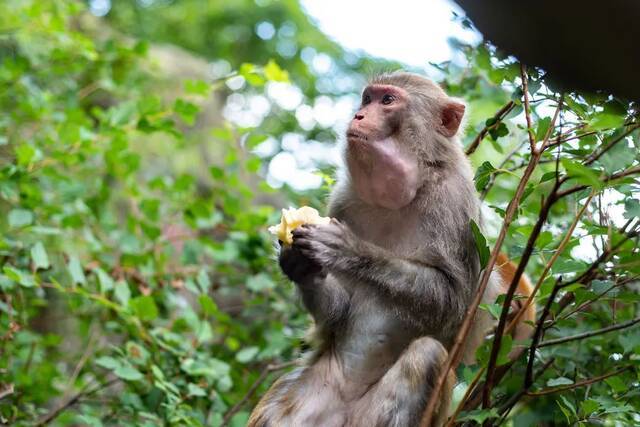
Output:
[{"xmin": 0, "ymin": 1, "xmax": 306, "ymax": 425}]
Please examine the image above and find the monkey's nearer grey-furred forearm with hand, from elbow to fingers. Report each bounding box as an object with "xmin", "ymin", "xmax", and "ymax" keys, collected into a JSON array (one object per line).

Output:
[{"xmin": 294, "ymin": 221, "xmax": 472, "ymax": 325}]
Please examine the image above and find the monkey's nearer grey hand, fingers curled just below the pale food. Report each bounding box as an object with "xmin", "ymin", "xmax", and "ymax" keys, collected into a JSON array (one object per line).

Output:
[{"xmin": 293, "ymin": 219, "xmax": 359, "ymax": 268}]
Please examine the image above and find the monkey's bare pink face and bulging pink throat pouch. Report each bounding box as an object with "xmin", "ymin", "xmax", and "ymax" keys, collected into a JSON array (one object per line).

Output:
[{"xmin": 347, "ymin": 85, "xmax": 420, "ymax": 210}]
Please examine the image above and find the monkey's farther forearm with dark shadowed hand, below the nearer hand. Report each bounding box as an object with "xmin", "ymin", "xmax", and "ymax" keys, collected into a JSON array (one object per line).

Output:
[{"xmin": 279, "ymin": 243, "xmax": 349, "ymax": 325}]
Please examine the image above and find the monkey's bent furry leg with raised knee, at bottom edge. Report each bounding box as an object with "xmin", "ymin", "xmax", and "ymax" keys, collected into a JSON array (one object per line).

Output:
[{"xmin": 348, "ymin": 337, "xmax": 455, "ymax": 427}]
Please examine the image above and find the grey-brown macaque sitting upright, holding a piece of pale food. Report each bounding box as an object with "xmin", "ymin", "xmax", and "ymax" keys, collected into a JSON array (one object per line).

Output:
[{"xmin": 249, "ymin": 73, "xmax": 536, "ymax": 427}]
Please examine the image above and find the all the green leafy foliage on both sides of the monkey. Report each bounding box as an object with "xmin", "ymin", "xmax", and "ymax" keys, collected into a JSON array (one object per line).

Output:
[{"xmin": 0, "ymin": 0, "xmax": 640, "ymax": 426}]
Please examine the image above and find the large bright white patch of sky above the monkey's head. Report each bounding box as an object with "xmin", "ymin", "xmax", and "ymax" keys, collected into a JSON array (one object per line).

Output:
[{"xmin": 302, "ymin": 0, "xmax": 480, "ymax": 67}]
